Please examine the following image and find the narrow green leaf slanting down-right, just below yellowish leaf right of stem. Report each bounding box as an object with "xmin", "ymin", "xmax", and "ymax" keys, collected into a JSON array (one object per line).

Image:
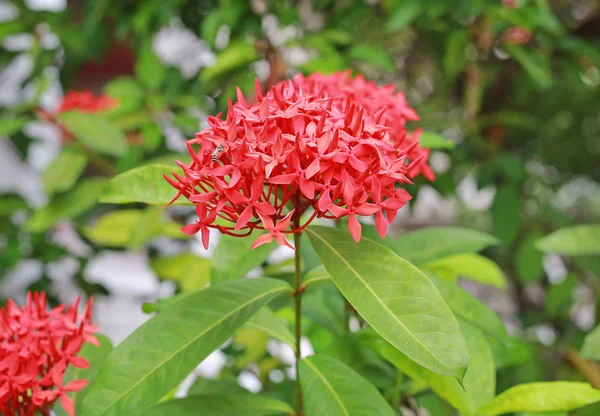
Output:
[{"xmin": 428, "ymin": 274, "xmax": 508, "ymax": 342}]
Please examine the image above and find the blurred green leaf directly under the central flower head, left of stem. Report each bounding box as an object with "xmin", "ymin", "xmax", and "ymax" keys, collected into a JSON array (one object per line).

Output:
[{"xmin": 211, "ymin": 234, "xmax": 274, "ymax": 283}]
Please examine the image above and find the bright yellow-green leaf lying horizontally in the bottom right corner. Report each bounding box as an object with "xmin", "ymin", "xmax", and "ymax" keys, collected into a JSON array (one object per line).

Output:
[{"xmin": 478, "ymin": 381, "xmax": 600, "ymax": 416}]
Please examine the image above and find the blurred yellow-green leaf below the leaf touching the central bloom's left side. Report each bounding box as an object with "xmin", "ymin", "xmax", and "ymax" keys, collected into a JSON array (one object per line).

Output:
[{"xmin": 83, "ymin": 208, "xmax": 187, "ymax": 249}]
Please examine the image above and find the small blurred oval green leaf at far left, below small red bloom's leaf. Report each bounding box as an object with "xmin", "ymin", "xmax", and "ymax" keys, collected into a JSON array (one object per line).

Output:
[{"xmin": 42, "ymin": 147, "xmax": 87, "ymax": 196}]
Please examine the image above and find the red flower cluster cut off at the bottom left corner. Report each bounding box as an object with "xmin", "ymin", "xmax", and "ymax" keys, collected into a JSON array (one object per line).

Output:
[{"xmin": 0, "ymin": 293, "xmax": 99, "ymax": 416}]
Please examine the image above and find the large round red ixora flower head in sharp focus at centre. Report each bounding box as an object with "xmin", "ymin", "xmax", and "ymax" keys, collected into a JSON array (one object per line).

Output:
[{"xmin": 165, "ymin": 72, "xmax": 435, "ymax": 248}]
